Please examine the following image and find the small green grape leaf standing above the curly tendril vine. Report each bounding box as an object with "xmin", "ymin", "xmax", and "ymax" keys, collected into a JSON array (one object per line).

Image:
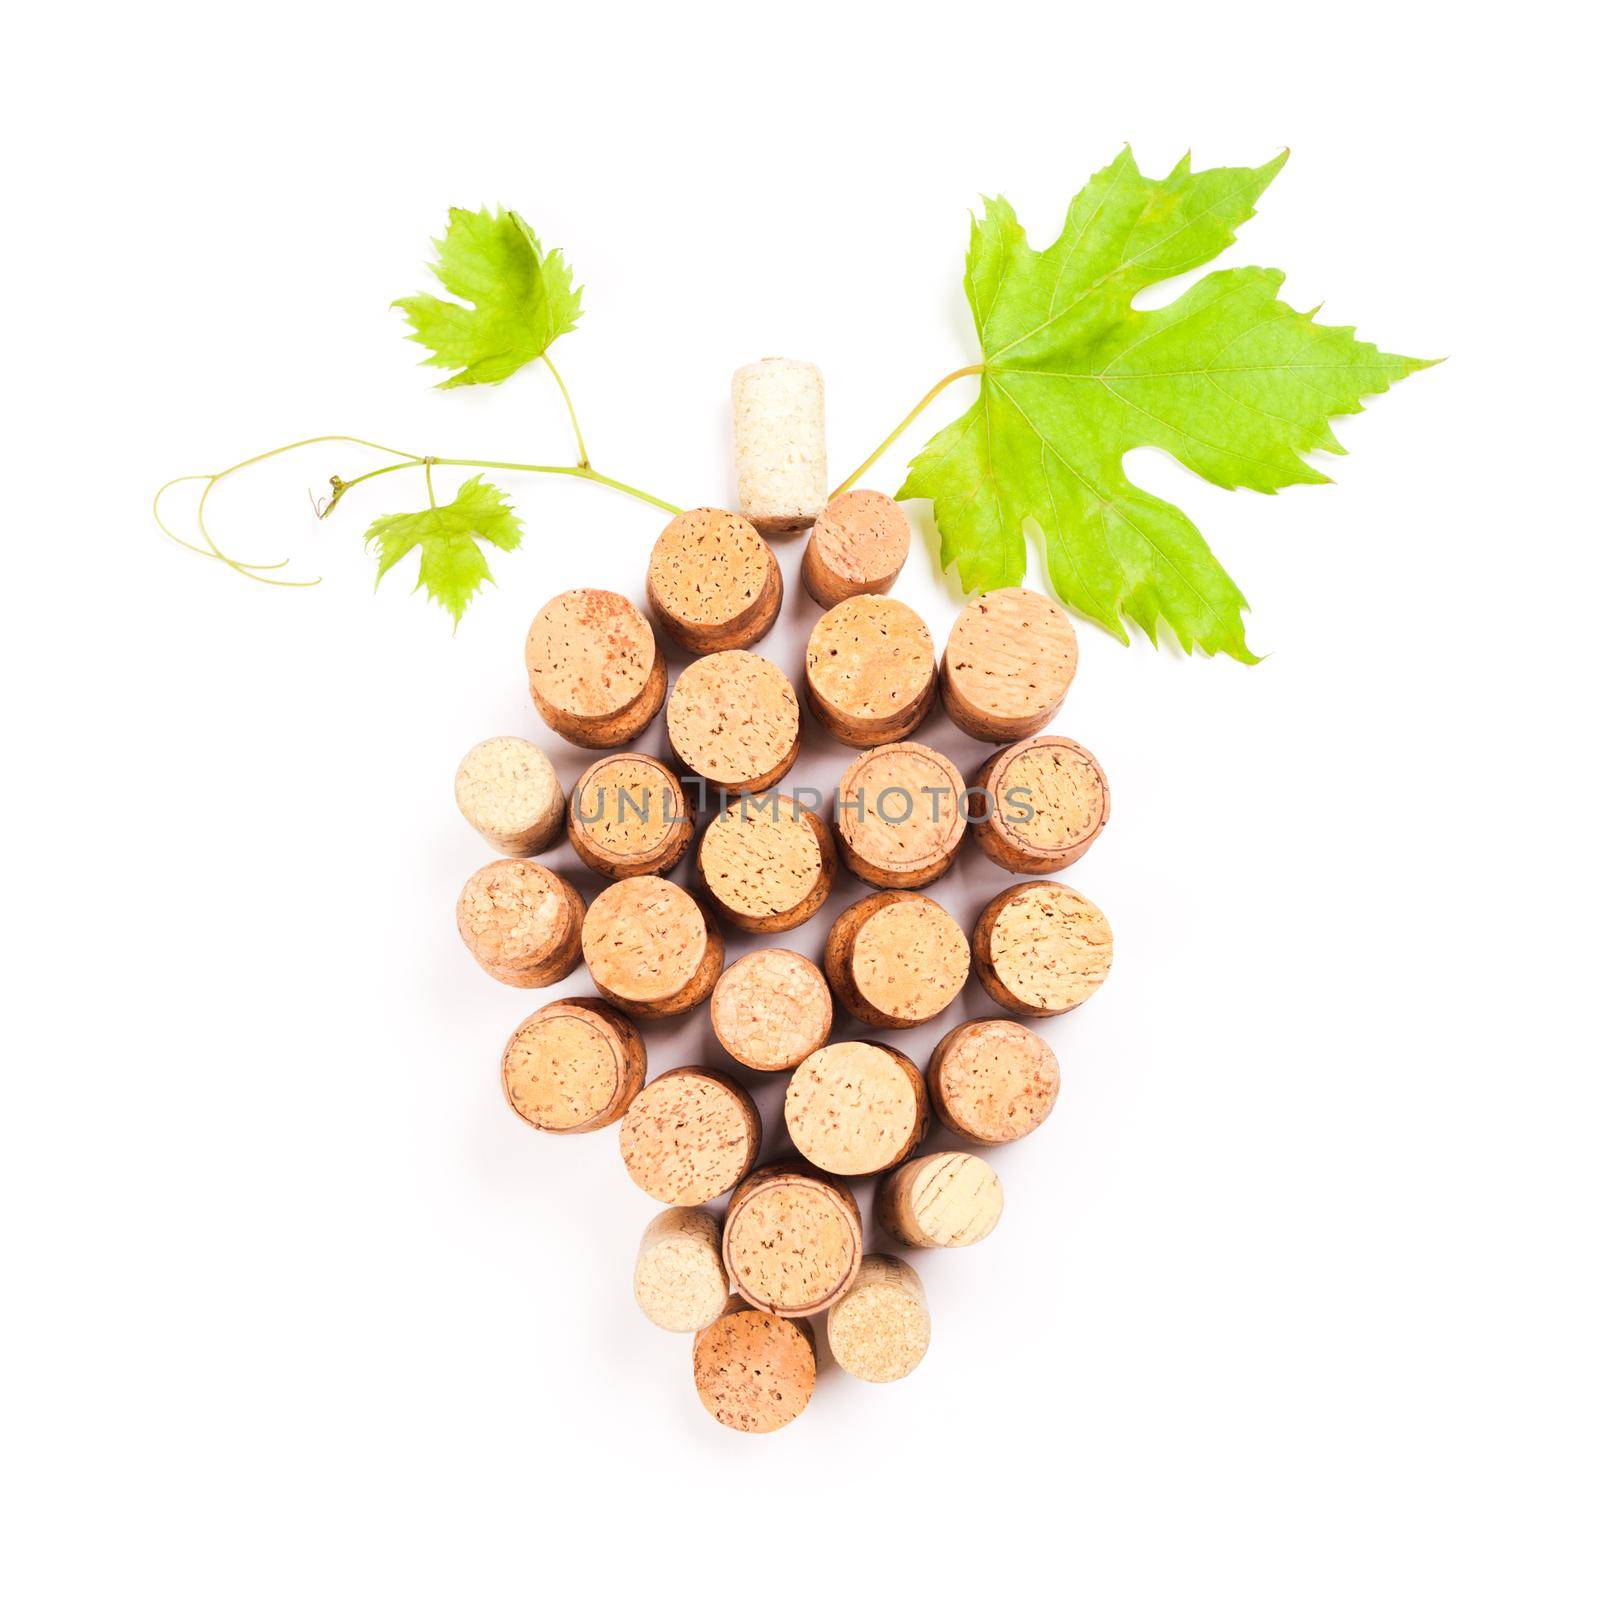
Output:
[{"xmin": 395, "ymin": 210, "xmax": 584, "ymax": 389}]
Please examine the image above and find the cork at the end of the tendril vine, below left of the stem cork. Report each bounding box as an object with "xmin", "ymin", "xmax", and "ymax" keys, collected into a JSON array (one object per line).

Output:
[{"xmin": 646, "ymin": 507, "xmax": 784, "ymax": 653}]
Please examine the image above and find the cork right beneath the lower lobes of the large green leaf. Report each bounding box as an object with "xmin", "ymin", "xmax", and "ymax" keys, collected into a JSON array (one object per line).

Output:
[{"xmin": 939, "ymin": 589, "xmax": 1078, "ymax": 744}]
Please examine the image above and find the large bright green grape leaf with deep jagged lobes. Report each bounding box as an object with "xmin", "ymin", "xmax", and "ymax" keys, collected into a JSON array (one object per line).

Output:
[{"xmin": 899, "ymin": 149, "xmax": 1432, "ymax": 662}]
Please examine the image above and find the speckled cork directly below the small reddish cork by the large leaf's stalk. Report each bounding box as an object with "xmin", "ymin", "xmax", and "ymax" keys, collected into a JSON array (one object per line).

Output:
[{"xmin": 805, "ymin": 595, "xmax": 938, "ymax": 747}]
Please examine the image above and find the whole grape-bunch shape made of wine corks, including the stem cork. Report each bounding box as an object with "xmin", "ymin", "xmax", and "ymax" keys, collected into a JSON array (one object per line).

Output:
[{"xmin": 456, "ymin": 360, "xmax": 1112, "ymax": 1434}]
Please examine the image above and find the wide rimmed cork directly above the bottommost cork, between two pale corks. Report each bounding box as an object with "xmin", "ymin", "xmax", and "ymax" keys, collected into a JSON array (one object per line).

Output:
[{"xmin": 722, "ymin": 1162, "xmax": 861, "ymax": 1317}]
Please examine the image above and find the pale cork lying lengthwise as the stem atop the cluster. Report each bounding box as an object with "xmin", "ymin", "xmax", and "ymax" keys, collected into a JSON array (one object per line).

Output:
[{"xmin": 733, "ymin": 355, "xmax": 827, "ymax": 533}]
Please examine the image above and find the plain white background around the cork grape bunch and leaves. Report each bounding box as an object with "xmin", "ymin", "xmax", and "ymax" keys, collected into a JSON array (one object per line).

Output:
[{"xmin": 0, "ymin": 0, "xmax": 1600, "ymax": 1600}]
